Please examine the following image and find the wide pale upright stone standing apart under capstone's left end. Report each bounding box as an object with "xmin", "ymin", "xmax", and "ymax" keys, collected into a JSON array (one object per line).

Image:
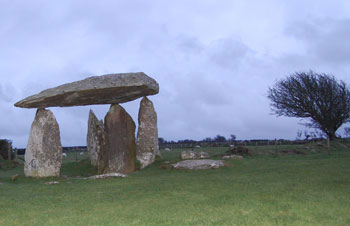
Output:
[{"xmin": 24, "ymin": 109, "xmax": 62, "ymax": 177}]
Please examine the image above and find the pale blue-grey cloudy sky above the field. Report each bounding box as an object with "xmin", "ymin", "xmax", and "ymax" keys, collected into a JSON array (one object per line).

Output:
[{"xmin": 0, "ymin": 0, "xmax": 350, "ymax": 148}]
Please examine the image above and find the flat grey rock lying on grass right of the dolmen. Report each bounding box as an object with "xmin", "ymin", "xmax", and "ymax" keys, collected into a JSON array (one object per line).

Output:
[{"xmin": 173, "ymin": 159, "xmax": 224, "ymax": 170}]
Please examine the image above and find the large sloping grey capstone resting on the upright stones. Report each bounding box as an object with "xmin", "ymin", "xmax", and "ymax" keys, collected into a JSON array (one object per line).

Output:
[{"xmin": 15, "ymin": 72, "xmax": 159, "ymax": 108}]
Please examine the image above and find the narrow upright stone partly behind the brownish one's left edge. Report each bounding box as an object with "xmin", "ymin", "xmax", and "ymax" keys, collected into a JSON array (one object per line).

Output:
[{"xmin": 86, "ymin": 110, "xmax": 104, "ymax": 167}]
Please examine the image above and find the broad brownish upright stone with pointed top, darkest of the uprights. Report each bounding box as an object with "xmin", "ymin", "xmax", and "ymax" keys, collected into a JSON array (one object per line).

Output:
[{"xmin": 100, "ymin": 104, "xmax": 136, "ymax": 174}]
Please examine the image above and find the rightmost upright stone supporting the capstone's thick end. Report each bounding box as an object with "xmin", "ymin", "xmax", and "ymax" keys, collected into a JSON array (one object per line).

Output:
[{"xmin": 136, "ymin": 97, "xmax": 160, "ymax": 169}]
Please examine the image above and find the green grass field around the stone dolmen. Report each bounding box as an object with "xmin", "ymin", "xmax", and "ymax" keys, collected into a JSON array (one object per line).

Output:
[{"xmin": 0, "ymin": 144, "xmax": 350, "ymax": 226}]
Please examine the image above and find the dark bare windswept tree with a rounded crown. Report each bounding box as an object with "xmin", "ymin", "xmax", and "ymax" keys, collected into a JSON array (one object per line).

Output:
[{"xmin": 268, "ymin": 71, "xmax": 350, "ymax": 140}]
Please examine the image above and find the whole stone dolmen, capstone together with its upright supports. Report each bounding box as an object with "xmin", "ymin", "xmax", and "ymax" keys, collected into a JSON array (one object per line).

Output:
[{"xmin": 15, "ymin": 72, "xmax": 160, "ymax": 177}]
